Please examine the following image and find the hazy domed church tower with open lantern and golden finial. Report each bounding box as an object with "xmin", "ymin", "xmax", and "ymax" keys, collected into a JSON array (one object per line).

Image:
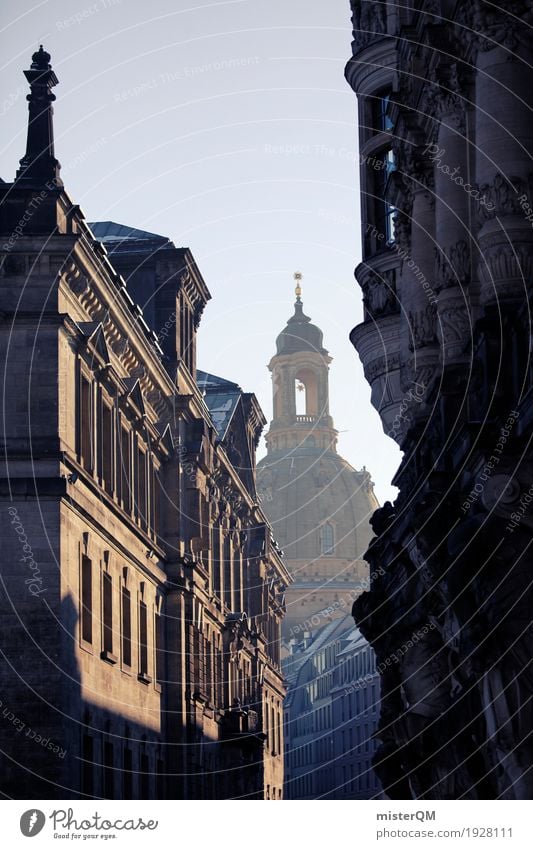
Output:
[{"xmin": 258, "ymin": 273, "xmax": 378, "ymax": 640}]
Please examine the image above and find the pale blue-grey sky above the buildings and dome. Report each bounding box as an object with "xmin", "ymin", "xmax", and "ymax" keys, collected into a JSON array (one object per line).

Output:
[{"xmin": 0, "ymin": 0, "xmax": 401, "ymax": 502}]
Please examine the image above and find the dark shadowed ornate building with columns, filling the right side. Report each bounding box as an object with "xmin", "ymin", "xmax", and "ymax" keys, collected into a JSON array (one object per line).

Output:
[{"xmin": 346, "ymin": 0, "xmax": 533, "ymax": 799}]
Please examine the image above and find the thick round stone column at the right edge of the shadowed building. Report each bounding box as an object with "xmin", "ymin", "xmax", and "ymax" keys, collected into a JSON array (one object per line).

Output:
[{"xmin": 476, "ymin": 29, "xmax": 533, "ymax": 304}]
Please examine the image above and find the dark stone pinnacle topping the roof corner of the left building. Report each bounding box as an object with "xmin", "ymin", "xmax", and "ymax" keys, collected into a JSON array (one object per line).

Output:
[{"xmin": 15, "ymin": 44, "xmax": 63, "ymax": 187}]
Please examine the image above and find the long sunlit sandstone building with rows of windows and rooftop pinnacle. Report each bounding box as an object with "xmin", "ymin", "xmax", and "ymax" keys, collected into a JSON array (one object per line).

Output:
[{"xmin": 0, "ymin": 48, "xmax": 290, "ymax": 799}]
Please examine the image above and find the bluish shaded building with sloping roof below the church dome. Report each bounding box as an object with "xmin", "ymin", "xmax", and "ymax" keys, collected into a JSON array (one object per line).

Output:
[{"xmin": 283, "ymin": 617, "xmax": 382, "ymax": 800}]
